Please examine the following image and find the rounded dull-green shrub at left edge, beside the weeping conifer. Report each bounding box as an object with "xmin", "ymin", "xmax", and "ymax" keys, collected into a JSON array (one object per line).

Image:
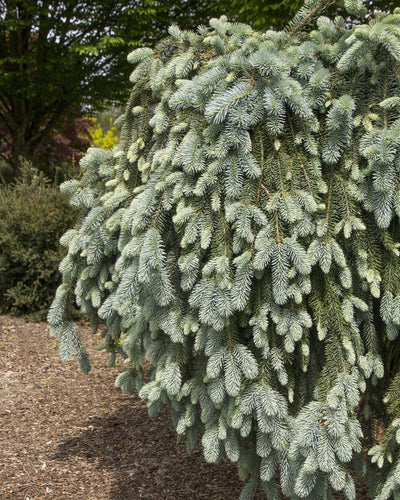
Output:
[{"xmin": 0, "ymin": 164, "xmax": 77, "ymax": 320}]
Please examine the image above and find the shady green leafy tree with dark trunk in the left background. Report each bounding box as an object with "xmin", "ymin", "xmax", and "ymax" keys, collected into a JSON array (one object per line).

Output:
[{"xmin": 0, "ymin": 0, "xmax": 216, "ymax": 178}]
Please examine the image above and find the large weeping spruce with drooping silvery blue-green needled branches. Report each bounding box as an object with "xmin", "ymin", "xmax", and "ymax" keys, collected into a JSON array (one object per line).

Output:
[{"xmin": 49, "ymin": 0, "xmax": 400, "ymax": 500}]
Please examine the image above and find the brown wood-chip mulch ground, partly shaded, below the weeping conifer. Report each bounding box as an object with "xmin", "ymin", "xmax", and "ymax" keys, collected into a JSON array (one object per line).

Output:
[{"xmin": 0, "ymin": 316, "xmax": 263, "ymax": 500}]
